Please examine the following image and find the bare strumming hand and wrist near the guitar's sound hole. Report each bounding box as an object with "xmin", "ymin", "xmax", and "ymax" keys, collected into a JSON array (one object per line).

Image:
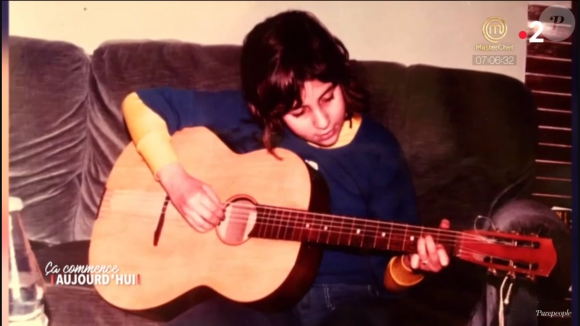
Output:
[{"xmin": 157, "ymin": 162, "xmax": 225, "ymax": 233}]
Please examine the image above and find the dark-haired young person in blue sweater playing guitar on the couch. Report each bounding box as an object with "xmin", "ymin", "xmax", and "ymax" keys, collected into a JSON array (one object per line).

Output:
[{"xmin": 122, "ymin": 11, "xmax": 449, "ymax": 326}]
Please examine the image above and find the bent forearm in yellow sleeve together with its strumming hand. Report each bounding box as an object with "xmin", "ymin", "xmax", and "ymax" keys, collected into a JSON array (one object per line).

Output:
[{"xmin": 122, "ymin": 93, "xmax": 225, "ymax": 232}]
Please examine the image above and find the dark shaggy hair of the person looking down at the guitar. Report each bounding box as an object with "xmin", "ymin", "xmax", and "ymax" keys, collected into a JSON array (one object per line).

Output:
[{"xmin": 240, "ymin": 10, "xmax": 367, "ymax": 152}]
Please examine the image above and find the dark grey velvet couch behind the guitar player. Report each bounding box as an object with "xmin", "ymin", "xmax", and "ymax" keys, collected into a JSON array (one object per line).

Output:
[{"xmin": 10, "ymin": 37, "xmax": 560, "ymax": 326}]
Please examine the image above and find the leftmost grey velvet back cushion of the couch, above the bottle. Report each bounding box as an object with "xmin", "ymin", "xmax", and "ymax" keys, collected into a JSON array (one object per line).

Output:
[{"xmin": 9, "ymin": 37, "xmax": 90, "ymax": 243}]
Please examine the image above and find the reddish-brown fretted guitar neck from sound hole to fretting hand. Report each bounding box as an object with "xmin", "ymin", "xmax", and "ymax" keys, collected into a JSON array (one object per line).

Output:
[{"xmin": 250, "ymin": 206, "xmax": 462, "ymax": 253}]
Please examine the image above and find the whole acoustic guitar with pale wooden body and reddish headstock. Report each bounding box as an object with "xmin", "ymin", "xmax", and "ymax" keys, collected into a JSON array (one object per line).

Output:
[{"xmin": 89, "ymin": 127, "xmax": 556, "ymax": 316}]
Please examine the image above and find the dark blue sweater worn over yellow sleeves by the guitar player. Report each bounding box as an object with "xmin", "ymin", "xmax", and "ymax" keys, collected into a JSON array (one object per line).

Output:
[{"xmin": 137, "ymin": 88, "xmax": 418, "ymax": 289}]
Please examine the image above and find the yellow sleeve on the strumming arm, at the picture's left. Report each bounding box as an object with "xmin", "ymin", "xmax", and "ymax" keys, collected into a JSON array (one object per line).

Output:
[{"xmin": 121, "ymin": 93, "xmax": 177, "ymax": 178}]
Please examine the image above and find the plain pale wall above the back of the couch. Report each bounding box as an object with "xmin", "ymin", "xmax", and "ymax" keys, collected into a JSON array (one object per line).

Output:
[{"xmin": 10, "ymin": 1, "xmax": 560, "ymax": 81}]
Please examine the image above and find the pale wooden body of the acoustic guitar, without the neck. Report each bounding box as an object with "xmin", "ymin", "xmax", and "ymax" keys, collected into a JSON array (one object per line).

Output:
[{"xmin": 89, "ymin": 127, "xmax": 329, "ymax": 319}]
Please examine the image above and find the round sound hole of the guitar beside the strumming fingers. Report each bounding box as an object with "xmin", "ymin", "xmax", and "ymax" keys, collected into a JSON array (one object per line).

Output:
[{"xmin": 216, "ymin": 198, "xmax": 258, "ymax": 246}]
